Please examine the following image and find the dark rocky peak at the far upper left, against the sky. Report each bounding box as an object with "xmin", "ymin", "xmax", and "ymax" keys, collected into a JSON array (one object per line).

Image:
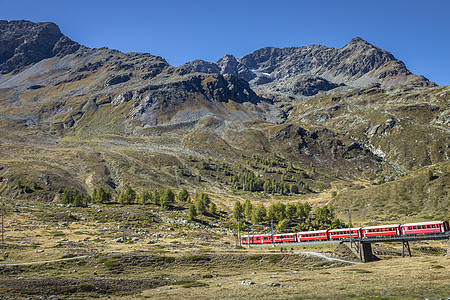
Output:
[{"xmin": 0, "ymin": 20, "xmax": 80, "ymax": 74}]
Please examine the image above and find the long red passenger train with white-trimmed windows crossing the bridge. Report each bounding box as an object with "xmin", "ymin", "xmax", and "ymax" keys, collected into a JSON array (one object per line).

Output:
[{"xmin": 242, "ymin": 221, "xmax": 450, "ymax": 245}]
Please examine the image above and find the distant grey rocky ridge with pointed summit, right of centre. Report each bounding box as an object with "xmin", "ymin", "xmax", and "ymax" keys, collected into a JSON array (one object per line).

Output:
[{"xmin": 181, "ymin": 37, "xmax": 436, "ymax": 96}]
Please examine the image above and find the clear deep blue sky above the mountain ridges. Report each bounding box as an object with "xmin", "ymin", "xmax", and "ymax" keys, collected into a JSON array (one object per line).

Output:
[{"xmin": 0, "ymin": 0, "xmax": 450, "ymax": 85}]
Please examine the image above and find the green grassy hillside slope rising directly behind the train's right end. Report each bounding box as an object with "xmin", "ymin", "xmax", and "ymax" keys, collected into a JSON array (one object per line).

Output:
[{"xmin": 331, "ymin": 162, "xmax": 450, "ymax": 224}]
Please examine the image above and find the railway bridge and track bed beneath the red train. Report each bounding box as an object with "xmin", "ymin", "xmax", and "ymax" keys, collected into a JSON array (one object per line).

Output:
[{"xmin": 246, "ymin": 231, "xmax": 450, "ymax": 262}]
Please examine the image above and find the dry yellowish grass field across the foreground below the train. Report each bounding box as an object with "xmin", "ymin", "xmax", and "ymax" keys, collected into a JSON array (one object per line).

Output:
[{"xmin": 0, "ymin": 200, "xmax": 450, "ymax": 299}]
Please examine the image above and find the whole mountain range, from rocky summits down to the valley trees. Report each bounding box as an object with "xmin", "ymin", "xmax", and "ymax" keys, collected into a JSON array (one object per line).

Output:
[{"xmin": 0, "ymin": 21, "xmax": 450, "ymax": 220}]
